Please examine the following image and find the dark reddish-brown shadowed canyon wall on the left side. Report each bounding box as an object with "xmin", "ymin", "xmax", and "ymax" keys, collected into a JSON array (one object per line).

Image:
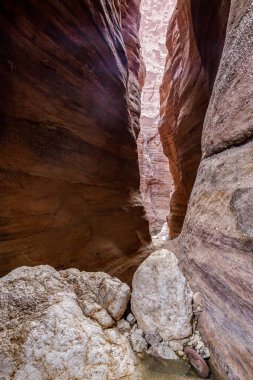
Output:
[{"xmin": 0, "ymin": 0, "xmax": 149, "ymax": 279}]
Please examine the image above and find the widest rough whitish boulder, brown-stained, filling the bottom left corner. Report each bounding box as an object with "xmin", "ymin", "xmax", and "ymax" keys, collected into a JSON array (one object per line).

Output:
[{"xmin": 0, "ymin": 266, "xmax": 137, "ymax": 380}]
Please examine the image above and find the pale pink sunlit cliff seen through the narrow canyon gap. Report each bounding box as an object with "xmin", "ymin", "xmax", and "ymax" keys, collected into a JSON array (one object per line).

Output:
[{"xmin": 138, "ymin": 0, "xmax": 176, "ymax": 233}]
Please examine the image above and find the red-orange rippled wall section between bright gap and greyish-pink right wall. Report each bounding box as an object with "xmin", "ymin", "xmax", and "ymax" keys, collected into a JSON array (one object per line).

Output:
[{"xmin": 160, "ymin": 0, "xmax": 230, "ymax": 237}]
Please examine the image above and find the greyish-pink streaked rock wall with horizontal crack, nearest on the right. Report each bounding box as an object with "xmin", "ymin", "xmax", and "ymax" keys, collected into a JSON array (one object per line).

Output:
[{"xmin": 180, "ymin": 1, "xmax": 253, "ymax": 379}]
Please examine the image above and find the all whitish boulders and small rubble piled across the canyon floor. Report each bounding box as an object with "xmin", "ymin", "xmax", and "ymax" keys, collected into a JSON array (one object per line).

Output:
[{"xmin": 0, "ymin": 249, "xmax": 209, "ymax": 380}]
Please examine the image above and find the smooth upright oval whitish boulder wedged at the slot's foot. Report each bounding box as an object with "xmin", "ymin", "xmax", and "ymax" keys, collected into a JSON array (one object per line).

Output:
[{"xmin": 131, "ymin": 249, "xmax": 192, "ymax": 341}]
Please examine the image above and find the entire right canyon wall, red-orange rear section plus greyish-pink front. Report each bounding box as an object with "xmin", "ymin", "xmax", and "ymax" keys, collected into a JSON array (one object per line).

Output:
[{"xmin": 160, "ymin": 0, "xmax": 253, "ymax": 380}]
